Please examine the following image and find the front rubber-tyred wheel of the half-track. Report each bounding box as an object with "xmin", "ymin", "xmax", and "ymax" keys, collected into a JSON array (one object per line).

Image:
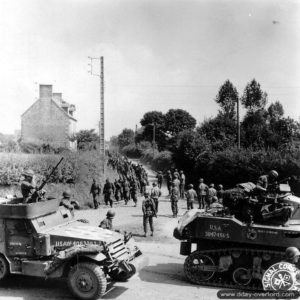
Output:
[{"xmin": 68, "ymin": 263, "xmax": 107, "ymax": 300}]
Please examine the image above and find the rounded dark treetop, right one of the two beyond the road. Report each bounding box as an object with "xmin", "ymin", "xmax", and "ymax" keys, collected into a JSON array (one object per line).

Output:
[{"xmin": 165, "ymin": 109, "xmax": 196, "ymax": 136}]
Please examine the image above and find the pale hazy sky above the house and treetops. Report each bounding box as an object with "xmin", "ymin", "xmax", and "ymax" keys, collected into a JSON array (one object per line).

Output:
[{"xmin": 0, "ymin": 0, "xmax": 300, "ymax": 139}]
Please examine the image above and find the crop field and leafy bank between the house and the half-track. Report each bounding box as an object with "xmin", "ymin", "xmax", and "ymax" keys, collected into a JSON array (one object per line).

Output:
[{"xmin": 0, "ymin": 151, "xmax": 116, "ymax": 207}]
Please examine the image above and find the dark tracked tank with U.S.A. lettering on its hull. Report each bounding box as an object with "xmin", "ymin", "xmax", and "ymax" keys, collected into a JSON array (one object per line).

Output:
[{"xmin": 174, "ymin": 183, "xmax": 300, "ymax": 289}]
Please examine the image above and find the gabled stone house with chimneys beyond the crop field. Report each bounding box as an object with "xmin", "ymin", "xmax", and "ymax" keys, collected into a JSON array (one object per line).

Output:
[{"xmin": 21, "ymin": 85, "xmax": 77, "ymax": 150}]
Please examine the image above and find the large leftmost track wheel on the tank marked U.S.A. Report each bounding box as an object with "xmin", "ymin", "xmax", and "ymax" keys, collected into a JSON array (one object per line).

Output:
[{"xmin": 184, "ymin": 251, "xmax": 216, "ymax": 284}]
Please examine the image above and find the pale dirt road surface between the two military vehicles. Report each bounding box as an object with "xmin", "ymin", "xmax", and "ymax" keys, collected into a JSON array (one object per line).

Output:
[{"xmin": 0, "ymin": 164, "xmax": 218, "ymax": 300}]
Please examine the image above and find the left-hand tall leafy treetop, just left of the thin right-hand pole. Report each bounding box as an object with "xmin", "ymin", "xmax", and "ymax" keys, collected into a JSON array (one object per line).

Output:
[{"xmin": 215, "ymin": 80, "xmax": 239, "ymax": 118}]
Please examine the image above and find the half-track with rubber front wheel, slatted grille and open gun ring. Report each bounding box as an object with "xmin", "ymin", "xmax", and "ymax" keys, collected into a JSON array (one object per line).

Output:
[{"xmin": 0, "ymin": 198, "xmax": 141, "ymax": 299}]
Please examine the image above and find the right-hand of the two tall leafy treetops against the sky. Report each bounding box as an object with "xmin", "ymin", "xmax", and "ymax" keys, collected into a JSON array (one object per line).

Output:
[{"xmin": 241, "ymin": 79, "xmax": 268, "ymax": 111}]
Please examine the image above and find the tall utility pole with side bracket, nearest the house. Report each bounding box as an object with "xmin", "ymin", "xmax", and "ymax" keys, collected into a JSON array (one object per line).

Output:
[{"xmin": 89, "ymin": 56, "xmax": 105, "ymax": 182}]
